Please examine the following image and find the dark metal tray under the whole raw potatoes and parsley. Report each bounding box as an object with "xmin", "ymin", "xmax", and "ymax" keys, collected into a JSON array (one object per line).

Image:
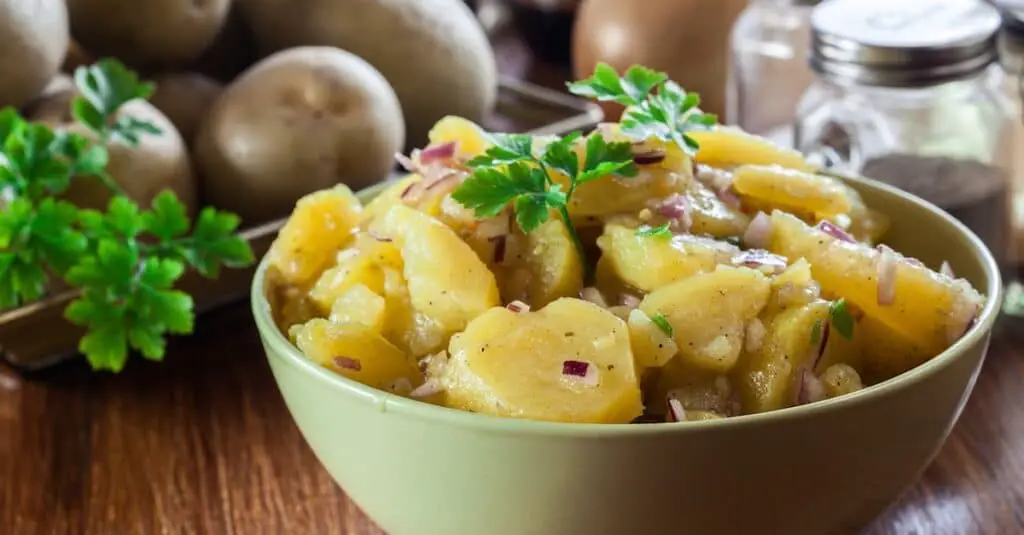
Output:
[{"xmin": 0, "ymin": 78, "xmax": 604, "ymax": 370}]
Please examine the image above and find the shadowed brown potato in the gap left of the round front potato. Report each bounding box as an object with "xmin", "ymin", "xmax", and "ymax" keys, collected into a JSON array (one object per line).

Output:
[{"xmin": 150, "ymin": 73, "xmax": 224, "ymax": 147}]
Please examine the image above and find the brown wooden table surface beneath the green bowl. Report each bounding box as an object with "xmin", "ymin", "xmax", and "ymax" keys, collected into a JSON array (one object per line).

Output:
[{"xmin": 0, "ymin": 19, "xmax": 1024, "ymax": 535}]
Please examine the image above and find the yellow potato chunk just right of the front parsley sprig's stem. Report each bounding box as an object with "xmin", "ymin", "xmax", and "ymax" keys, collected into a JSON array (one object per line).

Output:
[{"xmin": 597, "ymin": 223, "xmax": 739, "ymax": 292}]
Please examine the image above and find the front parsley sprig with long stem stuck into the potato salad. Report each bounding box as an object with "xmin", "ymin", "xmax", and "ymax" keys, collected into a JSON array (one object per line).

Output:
[{"xmin": 452, "ymin": 132, "xmax": 637, "ymax": 278}]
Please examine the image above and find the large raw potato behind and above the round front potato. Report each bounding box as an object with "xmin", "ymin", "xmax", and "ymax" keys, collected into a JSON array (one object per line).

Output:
[{"xmin": 241, "ymin": 0, "xmax": 498, "ymax": 147}]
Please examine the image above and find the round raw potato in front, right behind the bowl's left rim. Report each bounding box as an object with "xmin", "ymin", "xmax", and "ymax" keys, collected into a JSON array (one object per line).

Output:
[{"xmin": 196, "ymin": 46, "xmax": 406, "ymax": 222}]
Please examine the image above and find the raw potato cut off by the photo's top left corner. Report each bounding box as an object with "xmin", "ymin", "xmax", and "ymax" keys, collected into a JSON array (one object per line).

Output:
[{"xmin": 0, "ymin": 0, "xmax": 69, "ymax": 108}]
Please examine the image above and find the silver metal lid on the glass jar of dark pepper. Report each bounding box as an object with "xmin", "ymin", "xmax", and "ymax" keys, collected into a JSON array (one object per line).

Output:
[{"xmin": 810, "ymin": 0, "xmax": 1000, "ymax": 87}]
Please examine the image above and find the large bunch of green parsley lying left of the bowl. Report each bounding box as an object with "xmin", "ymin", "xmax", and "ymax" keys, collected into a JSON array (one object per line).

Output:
[{"xmin": 0, "ymin": 59, "xmax": 254, "ymax": 371}]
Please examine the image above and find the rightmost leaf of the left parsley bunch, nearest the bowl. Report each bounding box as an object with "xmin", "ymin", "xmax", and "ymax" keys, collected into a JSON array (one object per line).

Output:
[{"xmin": 184, "ymin": 206, "xmax": 255, "ymax": 278}]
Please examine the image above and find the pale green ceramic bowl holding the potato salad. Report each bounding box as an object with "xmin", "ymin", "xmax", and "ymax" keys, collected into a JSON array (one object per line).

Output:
[{"xmin": 252, "ymin": 174, "xmax": 1001, "ymax": 535}]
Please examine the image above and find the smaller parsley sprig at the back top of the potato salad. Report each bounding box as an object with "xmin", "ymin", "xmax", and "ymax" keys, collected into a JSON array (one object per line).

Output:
[{"xmin": 568, "ymin": 63, "xmax": 718, "ymax": 156}]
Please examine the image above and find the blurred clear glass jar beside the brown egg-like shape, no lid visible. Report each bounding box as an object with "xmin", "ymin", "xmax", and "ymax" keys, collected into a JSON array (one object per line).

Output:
[{"xmin": 726, "ymin": 0, "xmax": 821, "ymax": 147}]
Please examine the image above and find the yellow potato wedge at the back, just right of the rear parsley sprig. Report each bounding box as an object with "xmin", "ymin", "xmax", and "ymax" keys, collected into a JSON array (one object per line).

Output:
[{"xmin": 686, "ymin": 126, "xmax": 815, "ymax": 171}]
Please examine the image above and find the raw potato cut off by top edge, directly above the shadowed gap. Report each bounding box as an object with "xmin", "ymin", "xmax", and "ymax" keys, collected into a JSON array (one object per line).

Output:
[{"xmin": 67, "ymin": 0, "xmax": 231, "ymax": 66}]
